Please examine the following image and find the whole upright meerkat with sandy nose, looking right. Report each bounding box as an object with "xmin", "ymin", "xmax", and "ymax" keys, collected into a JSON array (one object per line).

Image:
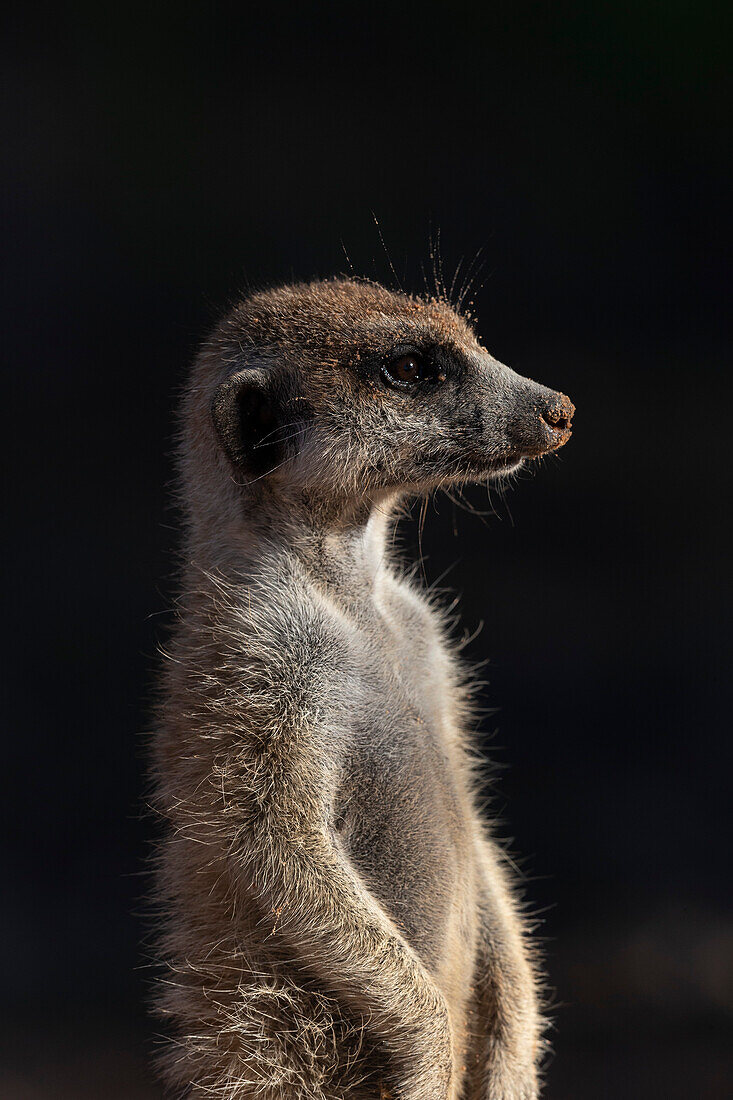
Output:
[{"xmin": 154, "ymin": 278, "xmax": 573, "ymax": 1100}]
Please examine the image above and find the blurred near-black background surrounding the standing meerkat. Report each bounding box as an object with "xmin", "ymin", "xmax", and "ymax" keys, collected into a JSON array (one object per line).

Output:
[{"xmin": 0, "ymin": 0, "xmax": 733, "ymax": 1100}]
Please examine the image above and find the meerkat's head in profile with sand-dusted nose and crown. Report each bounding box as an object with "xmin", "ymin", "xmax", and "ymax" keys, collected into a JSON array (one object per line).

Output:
[{"xmin": 181, "ymin": 279, "xmax": 575, "ymax": 525}]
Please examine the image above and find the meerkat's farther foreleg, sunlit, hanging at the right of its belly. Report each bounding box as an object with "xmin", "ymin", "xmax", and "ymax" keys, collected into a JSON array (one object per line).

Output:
[{"xmin": 464, "ymin": 842, "xmax": 543, "ymax": 1100}]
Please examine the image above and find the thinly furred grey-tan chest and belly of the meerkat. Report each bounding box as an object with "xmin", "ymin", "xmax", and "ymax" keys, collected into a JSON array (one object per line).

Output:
[{"xmin": 327, "ymin": 585, "xmax": 472, "ymax": 967}]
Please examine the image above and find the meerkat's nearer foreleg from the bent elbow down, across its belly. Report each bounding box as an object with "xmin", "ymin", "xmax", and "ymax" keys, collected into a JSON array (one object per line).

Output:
[{"xmin": 235, "ymin": 792, "xmax": 458, "ymax": 1100}]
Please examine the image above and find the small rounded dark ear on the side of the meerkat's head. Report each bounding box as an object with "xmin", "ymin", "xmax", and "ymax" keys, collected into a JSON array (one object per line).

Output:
[{"xmin": 211, "ymin": 367, "xmax": 285, "ymax": 476}]
